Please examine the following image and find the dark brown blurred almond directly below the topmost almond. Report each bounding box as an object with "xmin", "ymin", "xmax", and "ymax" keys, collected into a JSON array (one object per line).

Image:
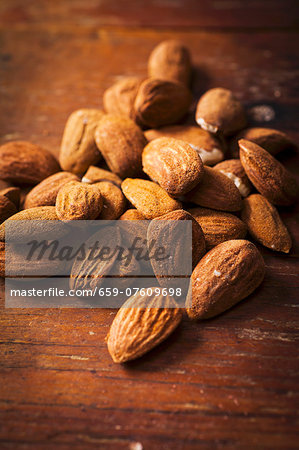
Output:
[{"xmin": 134, "ymin": 78, "xmax": 191, "ymax": 128}]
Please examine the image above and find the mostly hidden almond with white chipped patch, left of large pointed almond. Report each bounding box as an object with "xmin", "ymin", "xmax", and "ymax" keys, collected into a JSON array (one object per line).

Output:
[{"xmin": 214, "ymin": 159, "xmax": 252, "ymax": 197}]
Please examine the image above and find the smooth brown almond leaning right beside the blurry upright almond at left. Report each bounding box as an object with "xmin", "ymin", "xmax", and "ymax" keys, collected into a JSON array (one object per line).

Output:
[{"xmin": 95, "ymin": 114, "xmax": 147, "ymax": 178}]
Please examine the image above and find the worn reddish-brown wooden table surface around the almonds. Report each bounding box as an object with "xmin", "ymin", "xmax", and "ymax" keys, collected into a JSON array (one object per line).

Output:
[{"xmin": 0, "ymin": 0, "xmax": 299, "ymax": 450}]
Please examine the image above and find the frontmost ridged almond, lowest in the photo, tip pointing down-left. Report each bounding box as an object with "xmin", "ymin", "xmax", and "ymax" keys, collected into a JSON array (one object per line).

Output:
[{"xmin": 106, "ymin": 288, "xmax": 182, "ymax": 363}]
